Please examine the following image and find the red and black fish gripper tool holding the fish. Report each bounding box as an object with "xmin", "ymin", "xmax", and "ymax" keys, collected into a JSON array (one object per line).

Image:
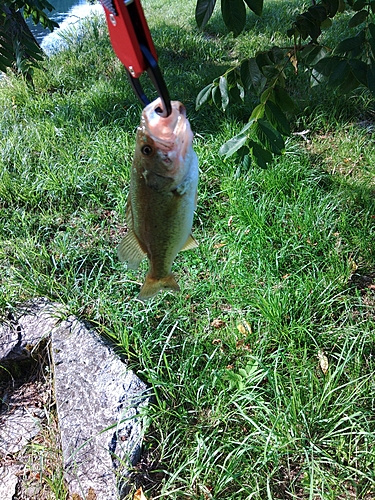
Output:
[{"xmin": 101, "ymin": 0, "xmax": 172, "ymax": 116}]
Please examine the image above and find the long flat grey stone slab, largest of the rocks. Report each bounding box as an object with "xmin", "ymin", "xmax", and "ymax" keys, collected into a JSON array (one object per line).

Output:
[{"xmin": 52, "ymin": 317, "xmax": 148, "ymax": 500}]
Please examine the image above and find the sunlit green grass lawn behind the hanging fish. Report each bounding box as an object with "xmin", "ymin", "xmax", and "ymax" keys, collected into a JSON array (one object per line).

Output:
[{"xmin": 0, "ymin": 0, "xmax": 375, "ymax": 500}]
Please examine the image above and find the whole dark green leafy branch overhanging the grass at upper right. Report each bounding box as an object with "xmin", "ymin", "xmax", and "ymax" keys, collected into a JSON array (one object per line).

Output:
[{"xmin": 196, "ymin": 0, "xmax": 375, "ymax": 168}]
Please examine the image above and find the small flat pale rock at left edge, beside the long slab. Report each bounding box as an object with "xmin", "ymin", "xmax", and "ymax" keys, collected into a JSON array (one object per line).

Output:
[{"xmin": 0, "ymin": 406, "xmax": 44, "ymax": 458}]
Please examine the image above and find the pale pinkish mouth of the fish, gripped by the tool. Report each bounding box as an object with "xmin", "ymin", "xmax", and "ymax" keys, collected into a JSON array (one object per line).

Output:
[{"xmin": 141, "ymin": 98, "xmax": 193, "ymax": 157}]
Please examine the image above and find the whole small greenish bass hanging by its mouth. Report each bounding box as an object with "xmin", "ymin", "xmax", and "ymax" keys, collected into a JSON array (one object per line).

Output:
[{"xmin": 117, "ymin": 98, "xmax": 199, "ymax": 301}]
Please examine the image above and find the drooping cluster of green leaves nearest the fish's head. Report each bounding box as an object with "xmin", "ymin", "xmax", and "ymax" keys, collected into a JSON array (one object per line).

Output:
[{"xmin": 197, "ymin": 47, "xmax": 295, "ymax": 168}]
